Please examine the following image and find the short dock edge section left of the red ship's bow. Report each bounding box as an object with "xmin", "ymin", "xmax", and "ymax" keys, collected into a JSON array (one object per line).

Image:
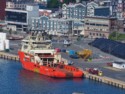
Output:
[{"xmin": 0, "ymin": 52, "xmax": 19, "ymax": 61}]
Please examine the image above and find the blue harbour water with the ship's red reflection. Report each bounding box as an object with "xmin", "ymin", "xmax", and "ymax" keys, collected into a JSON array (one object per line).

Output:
[{"xmin": 0, "ymin": 59, "xmax": 125, "ymax": 94}]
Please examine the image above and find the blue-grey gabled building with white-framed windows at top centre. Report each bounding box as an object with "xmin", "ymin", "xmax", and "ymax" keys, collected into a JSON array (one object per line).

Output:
[{"xmin": 62, "ymin": 3, "xmax": 86, "ymax": 20}]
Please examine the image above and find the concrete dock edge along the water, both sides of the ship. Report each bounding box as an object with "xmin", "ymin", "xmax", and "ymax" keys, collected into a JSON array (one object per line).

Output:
[{"xmin": 0, "ymin": 52, "xmax": 125, "ymax": 89}]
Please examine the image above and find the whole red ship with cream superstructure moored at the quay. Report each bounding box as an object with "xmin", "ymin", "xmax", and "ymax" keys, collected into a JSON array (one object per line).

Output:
[{"xmin": 18, "ymin": 34, "xmax": 84, "ymax": 78}]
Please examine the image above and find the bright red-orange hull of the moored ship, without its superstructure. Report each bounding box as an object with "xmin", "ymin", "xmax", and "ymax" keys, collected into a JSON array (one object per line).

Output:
[{"xmin": 18, "ymin": 51, "xmax": 84, "ymax": 78}]
